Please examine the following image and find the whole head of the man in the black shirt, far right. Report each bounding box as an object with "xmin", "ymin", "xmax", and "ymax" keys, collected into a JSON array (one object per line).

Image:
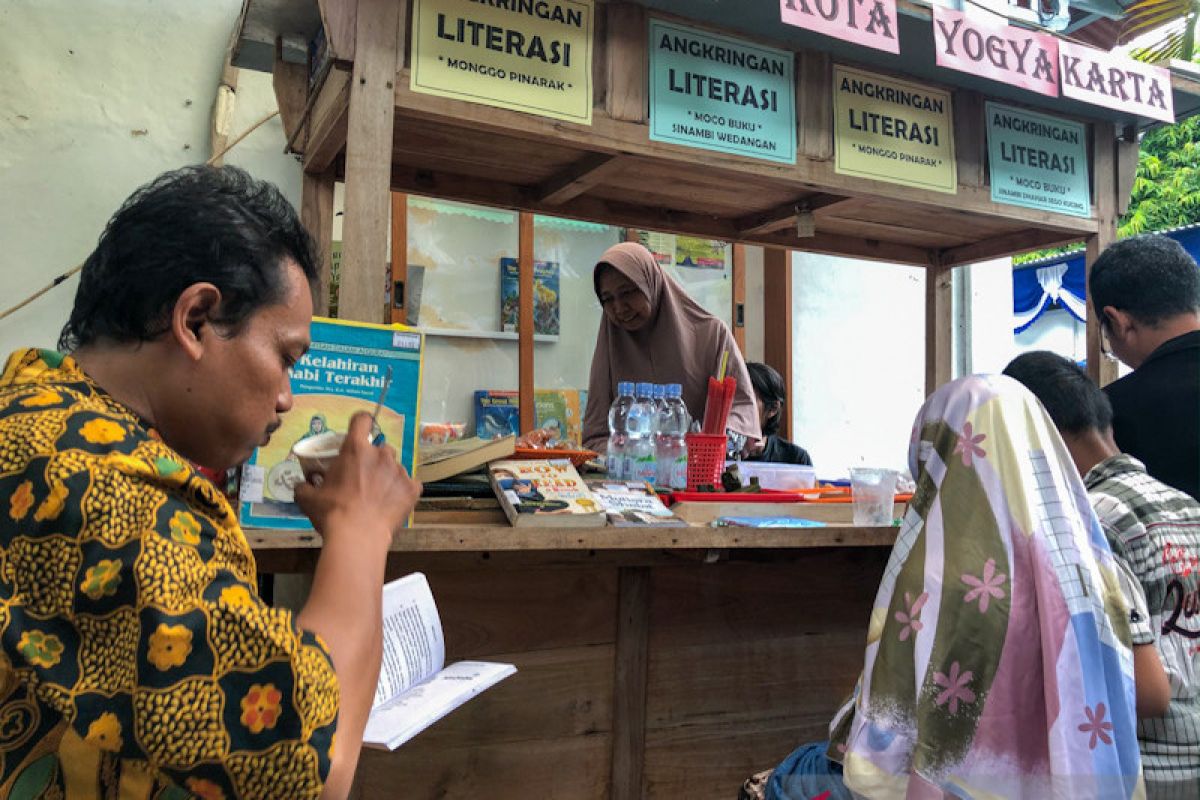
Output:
[{"xmin": 1087, "ymin": 234, "xmax": 1200, "ymax": 368}]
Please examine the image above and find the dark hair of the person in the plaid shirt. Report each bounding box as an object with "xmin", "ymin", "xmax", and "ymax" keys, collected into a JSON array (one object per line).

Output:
[{"xmin": 1004, "ymin": 350, "xmax": 1112, "ymax": 433}]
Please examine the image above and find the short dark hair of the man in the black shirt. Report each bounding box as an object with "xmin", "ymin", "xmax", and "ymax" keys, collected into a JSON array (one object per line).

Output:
[{"xmin": 1087, "ymin": 234, "xmax": 1200, "ymax": 325}]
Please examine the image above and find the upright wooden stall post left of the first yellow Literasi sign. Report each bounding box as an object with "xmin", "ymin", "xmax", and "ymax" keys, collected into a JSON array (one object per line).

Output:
[{"xmin": 337, "ymin": 0, "xmax": 401, "ymax": 323}]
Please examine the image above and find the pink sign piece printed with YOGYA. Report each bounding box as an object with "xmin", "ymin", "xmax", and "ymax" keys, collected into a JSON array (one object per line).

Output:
[{"xmin": 934, "ymin": 6, "xmax": 1058, "ymax": 97}]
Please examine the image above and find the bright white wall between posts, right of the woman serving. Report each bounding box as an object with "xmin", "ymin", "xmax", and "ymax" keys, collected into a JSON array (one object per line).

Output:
[{"xmin": 792, "ymin": 253, "xmax": 925, "ymax": 477}]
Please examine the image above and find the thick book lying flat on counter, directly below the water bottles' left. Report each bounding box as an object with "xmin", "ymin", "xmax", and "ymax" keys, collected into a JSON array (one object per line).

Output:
[{"xmin": 487, "ymin": 458, "xmax": 605, "ymax": 528}]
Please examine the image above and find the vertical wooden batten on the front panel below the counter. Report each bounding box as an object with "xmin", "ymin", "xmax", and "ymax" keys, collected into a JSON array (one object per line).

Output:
[{"xmin": 610, "ymin": 567, "xmax": 652, "ymax": 800}]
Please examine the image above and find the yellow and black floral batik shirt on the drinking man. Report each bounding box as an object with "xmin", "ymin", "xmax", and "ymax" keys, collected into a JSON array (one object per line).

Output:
[{"xmin": 0, "ymin": 350, "xmax": 338, "ymax": 800}]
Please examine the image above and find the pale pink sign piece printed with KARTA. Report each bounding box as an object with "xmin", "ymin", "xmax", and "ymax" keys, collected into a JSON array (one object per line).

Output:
[{"xmin": 1058, "ymin": 41, "xmax": 1175, "ymax": 122}]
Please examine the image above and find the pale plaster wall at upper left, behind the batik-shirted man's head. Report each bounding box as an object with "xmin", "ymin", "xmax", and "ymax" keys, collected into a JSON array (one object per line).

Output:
[{"xmin": 0, "ymin": 0, "xmax": 300, "ymax": 357}]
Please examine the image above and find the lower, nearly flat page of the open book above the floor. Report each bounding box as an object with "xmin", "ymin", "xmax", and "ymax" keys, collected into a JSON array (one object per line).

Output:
[{"xmin": 362, "ymin": 661, "xmax": 517, "ymax": 750}]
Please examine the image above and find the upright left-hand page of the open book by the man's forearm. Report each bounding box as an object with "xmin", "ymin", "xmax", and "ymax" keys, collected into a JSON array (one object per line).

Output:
[{"xmin": 373, "ymin": 572, "xmax": 446, "ymax": 708}]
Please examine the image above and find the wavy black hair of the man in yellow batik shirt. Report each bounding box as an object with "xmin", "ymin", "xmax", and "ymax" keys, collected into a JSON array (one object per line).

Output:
[{"xmin": 59, "ymin": 167, "xmax": 317, "ymax": 351}]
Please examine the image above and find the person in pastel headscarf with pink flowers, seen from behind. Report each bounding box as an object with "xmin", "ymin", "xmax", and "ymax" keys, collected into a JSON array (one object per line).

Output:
[{"xmin": 766, "ymin": 375, "xmax": 1144, "ymax": 800}]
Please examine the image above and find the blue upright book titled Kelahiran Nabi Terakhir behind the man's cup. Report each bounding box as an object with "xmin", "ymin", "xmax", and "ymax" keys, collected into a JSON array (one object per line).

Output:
[{"xmin": 240, "ymin": 318, "xmax": 424, "ymax": 530}]
